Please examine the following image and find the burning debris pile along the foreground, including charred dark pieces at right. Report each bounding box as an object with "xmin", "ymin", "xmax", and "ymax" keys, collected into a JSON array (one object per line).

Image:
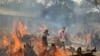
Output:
[{"xmin": 0, "ymin": 22, "xmax": 96, "ymax": 56}]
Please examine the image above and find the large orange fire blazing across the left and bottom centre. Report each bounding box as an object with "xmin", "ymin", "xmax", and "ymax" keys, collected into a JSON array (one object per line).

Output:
[{"xmin": 3, "ymin": 22, "xmax": 71, "ymax": 56}]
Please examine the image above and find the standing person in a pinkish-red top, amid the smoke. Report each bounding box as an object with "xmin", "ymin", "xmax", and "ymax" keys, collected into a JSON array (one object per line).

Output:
[{"xmin": 58, "ymin": 27, "xmax": 66, "ymax": 49}]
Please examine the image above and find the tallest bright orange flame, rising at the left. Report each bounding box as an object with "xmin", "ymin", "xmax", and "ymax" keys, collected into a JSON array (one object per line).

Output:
[{"xmin": 11, "ymin": 22, "xmax": 26, "ymax": 56}]
